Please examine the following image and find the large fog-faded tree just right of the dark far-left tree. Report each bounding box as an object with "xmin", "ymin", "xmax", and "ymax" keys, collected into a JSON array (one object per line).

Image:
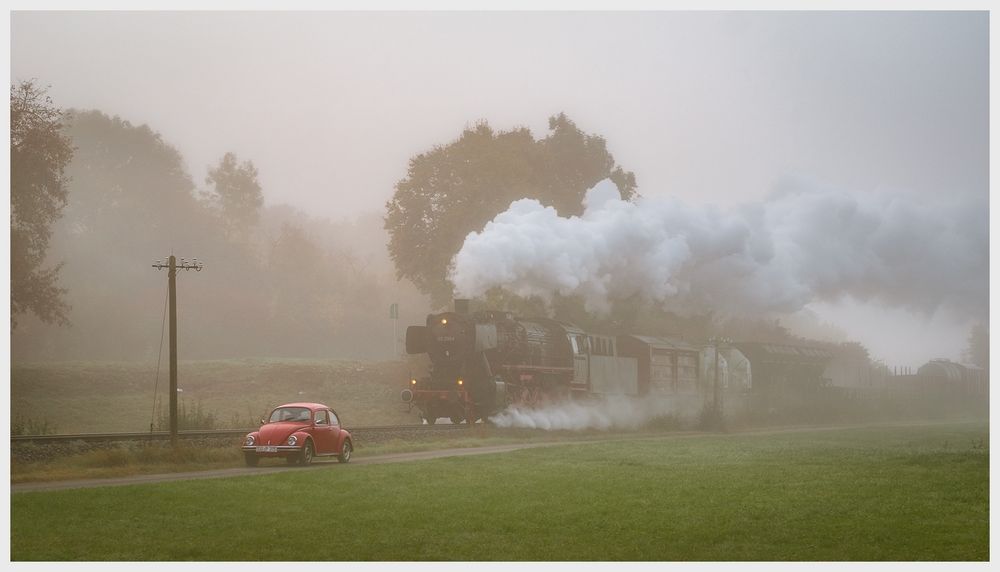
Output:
[{"xmin": 11, "ymin": 110, "xmax": 209, "ymax": 359}]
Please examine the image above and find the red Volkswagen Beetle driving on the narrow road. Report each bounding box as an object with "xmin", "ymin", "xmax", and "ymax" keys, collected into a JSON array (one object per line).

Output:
[{"xmin": 243, "ymin": 403, "xmax": 354, "ymax": 467}]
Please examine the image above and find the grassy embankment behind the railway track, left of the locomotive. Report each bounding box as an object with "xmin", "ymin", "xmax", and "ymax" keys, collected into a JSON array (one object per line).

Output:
[{"xmin": 11, "ymin": 359, "xmax": 420, "ymax": 433}]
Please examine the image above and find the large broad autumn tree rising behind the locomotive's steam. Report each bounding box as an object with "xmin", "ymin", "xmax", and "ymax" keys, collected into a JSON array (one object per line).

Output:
[{"xmin": 385, "ymin": 114, "xmax": 636, "ymax": 307}]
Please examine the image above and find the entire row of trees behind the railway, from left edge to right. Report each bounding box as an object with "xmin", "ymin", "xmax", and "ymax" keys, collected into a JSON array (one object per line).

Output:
[{"xmin": 19, "ymin": 89, "xmax": 956, "ymax": 361}]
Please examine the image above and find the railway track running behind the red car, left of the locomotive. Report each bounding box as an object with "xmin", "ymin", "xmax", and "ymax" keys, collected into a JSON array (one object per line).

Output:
[{"xmin": 10, "ymin": 425, "xmax": 469, "ymax": 445}]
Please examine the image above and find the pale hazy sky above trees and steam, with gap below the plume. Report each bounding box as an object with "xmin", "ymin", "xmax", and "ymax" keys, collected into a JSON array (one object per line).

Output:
[{"xmin": 11, "ymin": 12, "xmax": 989, "ymax": 363}]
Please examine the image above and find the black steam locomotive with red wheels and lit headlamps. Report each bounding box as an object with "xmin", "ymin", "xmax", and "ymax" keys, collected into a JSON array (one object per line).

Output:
[{"xmin": 402, "ymin": 300, "xmax": 589, "ymax": 424}]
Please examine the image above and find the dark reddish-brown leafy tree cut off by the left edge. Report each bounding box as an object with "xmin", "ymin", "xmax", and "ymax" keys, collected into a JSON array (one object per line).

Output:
[{"xmin": 10, "ymin": 81, "xmax": 73, "ymax": 331}]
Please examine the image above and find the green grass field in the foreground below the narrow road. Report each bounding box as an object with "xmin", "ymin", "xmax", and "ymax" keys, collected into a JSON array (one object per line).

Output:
[{"xmin": 11, "ymin": 423, "xmax": 989, "ymax": 561}]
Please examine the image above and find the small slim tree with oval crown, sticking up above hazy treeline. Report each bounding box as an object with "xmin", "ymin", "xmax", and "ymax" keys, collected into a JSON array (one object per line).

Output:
[{"xmin": 205, "ymin": 153, "xmax": 264, "ymax": 236}]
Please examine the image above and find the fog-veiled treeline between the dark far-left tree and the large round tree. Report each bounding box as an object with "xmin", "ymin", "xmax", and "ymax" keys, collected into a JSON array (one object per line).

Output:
[{"xmin": 11, "ymin": 110, "xmax": 428, "ymax": 361}]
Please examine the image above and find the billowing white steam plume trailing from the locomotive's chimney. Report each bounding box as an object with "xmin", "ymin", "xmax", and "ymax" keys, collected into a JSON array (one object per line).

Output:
[{"xmin": 450, "ymin": 180, "xmax": 989, "ymax": 317}]
